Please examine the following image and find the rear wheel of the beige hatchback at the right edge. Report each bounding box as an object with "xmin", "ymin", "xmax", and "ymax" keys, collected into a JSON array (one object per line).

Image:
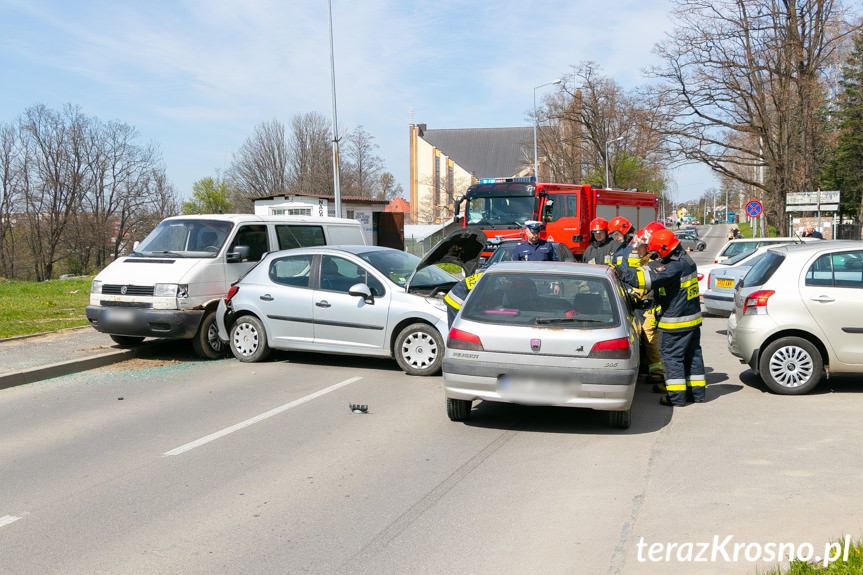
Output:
[{"xmin": 758, "ymin": 337, "xmax": 824, "ymax": 395}]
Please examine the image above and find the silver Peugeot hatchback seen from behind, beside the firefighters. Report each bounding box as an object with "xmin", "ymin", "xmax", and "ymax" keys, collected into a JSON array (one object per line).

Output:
[{"xmin": 443, "ymin": 262, "xmax": 639, "ymax": 428}]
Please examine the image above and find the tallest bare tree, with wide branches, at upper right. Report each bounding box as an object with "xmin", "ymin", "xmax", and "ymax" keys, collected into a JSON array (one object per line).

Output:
[{"xmin": 650, "ymin": 0, "xmax": 848, "ymax": 234}]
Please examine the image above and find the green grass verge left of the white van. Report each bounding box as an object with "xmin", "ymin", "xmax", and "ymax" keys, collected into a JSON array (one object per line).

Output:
[{"xmin": 0, "ymin": 276, "xmax": 93, "ymax": 338}]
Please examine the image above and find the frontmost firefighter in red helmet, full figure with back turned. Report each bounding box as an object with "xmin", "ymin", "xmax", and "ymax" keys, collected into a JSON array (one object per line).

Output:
[{"xmin": 615, "ymin": 230, "xmax": 706, "ymax": 405}]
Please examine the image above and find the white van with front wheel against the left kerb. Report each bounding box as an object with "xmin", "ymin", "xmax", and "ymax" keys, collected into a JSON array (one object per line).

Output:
[{"xmin": 86, "ymin": 214, "xmax": 366, "ymax": 359}]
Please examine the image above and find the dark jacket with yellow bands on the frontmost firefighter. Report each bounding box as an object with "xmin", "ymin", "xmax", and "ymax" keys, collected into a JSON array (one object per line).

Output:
[{"xmin": 616, "ymin": 247, "xmax": 701, "ymax": 332}]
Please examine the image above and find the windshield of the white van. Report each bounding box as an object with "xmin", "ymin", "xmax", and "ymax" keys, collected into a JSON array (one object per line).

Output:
[{"xmin": 132, "ymin": 219, "xmax": 234, "ymax": 258}]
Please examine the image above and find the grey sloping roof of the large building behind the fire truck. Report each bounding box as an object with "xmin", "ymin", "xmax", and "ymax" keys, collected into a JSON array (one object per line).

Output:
[{"xmin": 420, "ymin": 127, "xmax": 533, "ymax": 179}]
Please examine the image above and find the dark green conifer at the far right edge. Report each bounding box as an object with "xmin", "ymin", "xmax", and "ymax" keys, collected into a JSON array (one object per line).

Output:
[{"xmin": 821, "ymin": 24, "xmax": 863, "ymax": 223}]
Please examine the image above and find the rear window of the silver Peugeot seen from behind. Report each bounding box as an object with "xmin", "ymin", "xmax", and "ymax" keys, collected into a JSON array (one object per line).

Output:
[{"xmin": 462, "ymin": 272, "xmax": 620, "ymax": 329}]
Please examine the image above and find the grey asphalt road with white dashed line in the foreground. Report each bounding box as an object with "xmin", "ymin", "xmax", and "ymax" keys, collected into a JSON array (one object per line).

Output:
[{"xmin": 0, "ymin": 229, "xmax": 863, "ymax": 575}]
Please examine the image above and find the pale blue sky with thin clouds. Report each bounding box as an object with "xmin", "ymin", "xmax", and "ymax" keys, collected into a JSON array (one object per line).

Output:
[{"xmin": 0, "ymin": 0, "xmax": 718, "ymax": 205}]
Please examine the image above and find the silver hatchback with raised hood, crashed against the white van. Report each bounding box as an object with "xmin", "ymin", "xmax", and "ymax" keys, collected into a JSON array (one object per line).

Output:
[{"xmin": 216, "ymin": 244, "xmax": 466, "ymax": 375}]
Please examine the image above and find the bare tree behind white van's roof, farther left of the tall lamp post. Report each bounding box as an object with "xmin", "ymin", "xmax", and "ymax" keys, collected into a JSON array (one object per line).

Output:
[{"xmin": 225, "ymin": 119, "xmax": 291, "ymax": 212}]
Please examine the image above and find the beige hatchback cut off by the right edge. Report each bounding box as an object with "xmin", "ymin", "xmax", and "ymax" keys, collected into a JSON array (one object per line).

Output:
[{"xmin": 728, "ymin": 240, "xmax": 863, "ymax": 395}]
